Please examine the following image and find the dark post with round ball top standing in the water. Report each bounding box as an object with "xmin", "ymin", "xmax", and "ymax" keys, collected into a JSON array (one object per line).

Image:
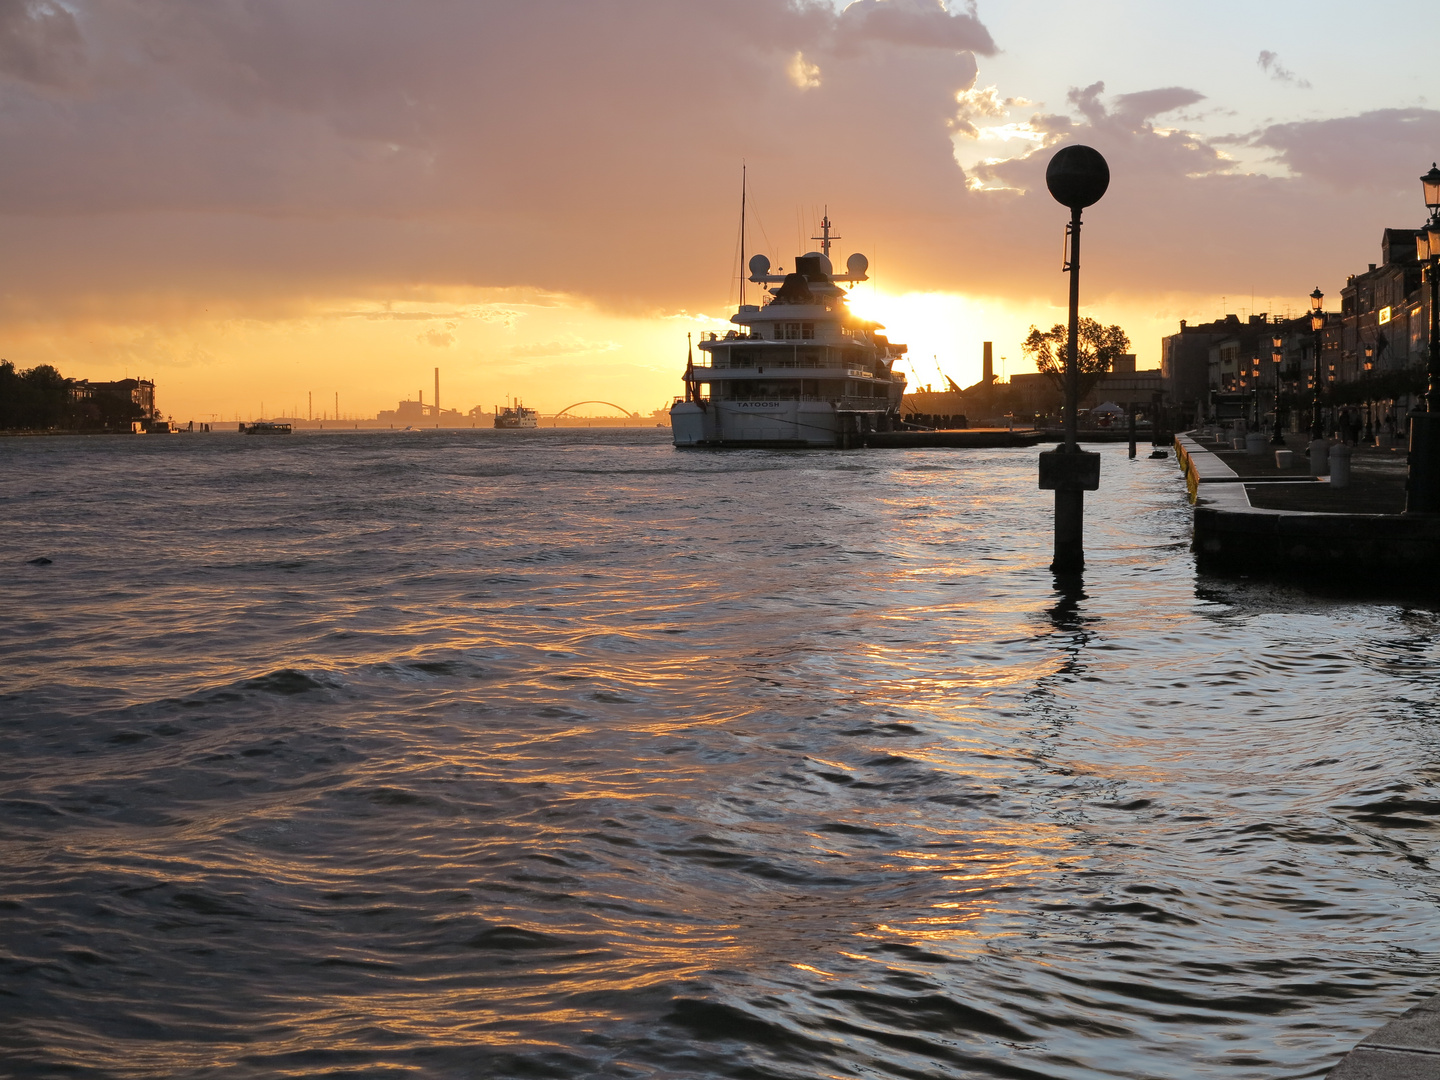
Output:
[{"xmin": 1040, "ymin": 145, "xmax": 1110, "ymax": 575}]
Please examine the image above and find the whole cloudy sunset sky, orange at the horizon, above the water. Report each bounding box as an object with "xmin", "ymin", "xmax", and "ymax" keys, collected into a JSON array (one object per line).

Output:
[{"xmin": 0, "ymin": 0, "xmax": 1440, "ymax": 420}]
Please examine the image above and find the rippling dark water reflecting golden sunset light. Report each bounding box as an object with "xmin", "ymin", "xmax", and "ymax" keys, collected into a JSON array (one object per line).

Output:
[{"xmin": 0, "ymin": 429, "xmax": 1440, "ymax": 1080}]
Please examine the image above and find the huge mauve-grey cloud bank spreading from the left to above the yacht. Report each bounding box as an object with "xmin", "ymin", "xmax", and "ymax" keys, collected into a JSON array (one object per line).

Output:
[{"xmin": 0, "ymin": 0, "xmax": 994, "ymax": 310}]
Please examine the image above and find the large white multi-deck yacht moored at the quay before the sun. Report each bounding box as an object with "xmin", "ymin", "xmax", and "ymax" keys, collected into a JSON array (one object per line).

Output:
[{"xmin": 670, "ymin": 216, "xmax": 906, "ymax": 448}]
